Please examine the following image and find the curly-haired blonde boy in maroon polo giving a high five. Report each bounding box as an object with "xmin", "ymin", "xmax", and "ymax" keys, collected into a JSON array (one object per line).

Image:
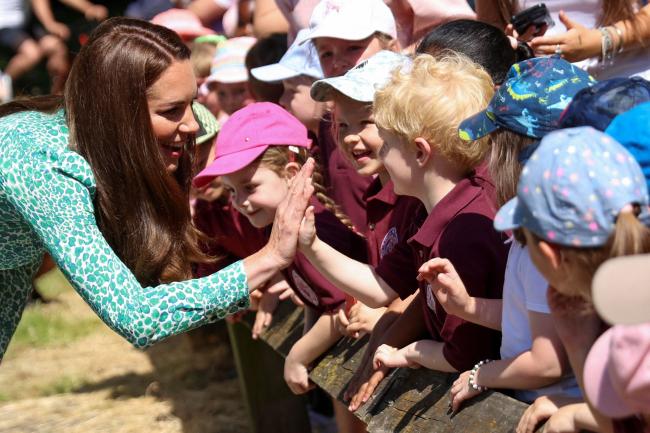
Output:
[{"xmin": 301, "ymin": 54, "xmax": 507, "ymax": 398}]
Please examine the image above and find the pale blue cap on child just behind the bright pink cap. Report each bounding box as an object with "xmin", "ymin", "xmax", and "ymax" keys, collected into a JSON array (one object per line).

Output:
[{"xmin": 251, "ymin": 29, "xmax": 323, "ymax": 83}]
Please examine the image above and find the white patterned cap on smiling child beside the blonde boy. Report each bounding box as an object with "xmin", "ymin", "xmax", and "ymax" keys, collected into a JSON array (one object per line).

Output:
[{"xmin": 311, "ymin": 50, "xmax": 411, "ymax": 103}]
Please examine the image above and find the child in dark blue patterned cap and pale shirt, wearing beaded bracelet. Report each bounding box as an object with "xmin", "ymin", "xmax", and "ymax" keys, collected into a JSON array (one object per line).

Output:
[{"xmin": 421, "ymin": 58, "xmax": 594, "ymax": 411}]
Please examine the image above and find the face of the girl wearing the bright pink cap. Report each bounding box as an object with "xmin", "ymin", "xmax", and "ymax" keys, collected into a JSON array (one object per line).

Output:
[{"xmin": 221, "ymin": 163, "xmax": 289, "ymax": 228}]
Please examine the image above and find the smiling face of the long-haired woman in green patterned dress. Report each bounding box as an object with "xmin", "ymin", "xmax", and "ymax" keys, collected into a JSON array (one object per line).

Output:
[{"xmin": 147, "ymin": 60, "xmax": 199, "ymax": 173}]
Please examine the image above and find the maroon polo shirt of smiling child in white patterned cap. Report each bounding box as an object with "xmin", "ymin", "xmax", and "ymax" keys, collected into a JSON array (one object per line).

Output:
[{"xmin": 364, "ymin": 177, "xmax": 427, "ymax": 266}]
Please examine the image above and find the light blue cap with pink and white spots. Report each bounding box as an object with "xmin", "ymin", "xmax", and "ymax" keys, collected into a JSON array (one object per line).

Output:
[{"xmin": 494, "ymin": 126, "xmax": 648, "ymax": 247}]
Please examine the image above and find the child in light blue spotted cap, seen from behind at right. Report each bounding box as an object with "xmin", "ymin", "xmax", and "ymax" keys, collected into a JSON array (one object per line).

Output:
[{"xmin": 495, "ymin": 127, "xmax": 650, "ymax": 431}]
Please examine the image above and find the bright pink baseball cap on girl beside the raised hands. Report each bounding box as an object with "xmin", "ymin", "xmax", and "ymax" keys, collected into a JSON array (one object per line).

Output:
[{"xmin": 193, "ymin": 102, "xmax": 311, "ymax": 188}]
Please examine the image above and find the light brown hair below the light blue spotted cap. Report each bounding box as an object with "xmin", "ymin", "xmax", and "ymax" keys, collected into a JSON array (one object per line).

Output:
[{"xmin": 531, "ymin": 206, "xmax": 650, "ymax": 299}]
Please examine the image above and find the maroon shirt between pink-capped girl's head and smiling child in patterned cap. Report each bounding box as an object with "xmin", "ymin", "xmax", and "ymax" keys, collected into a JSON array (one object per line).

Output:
[{"xmin": 313, "ymin": 117, "xmax": 372, "ymax": 233}]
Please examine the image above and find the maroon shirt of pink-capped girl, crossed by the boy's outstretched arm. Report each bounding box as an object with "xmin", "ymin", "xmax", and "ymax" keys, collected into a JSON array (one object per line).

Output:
[{"xmin": 284, "ymin": 198, "xmax": 366, "ymax": 313}]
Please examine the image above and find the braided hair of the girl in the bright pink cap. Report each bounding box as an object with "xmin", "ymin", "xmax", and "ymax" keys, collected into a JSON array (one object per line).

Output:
[{"xmin": 256, "ymin": 146, "xmax": 358, "ymax": 233}]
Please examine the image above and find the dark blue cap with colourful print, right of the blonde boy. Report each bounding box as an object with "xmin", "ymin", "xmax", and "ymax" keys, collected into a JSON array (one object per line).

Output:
[{"xmin": 458, "ymin": 56, "xmax": 596, "ymax": 141}]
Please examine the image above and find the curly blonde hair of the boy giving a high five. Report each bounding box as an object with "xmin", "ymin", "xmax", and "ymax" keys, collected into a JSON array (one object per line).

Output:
[{"xmin": 373, "ymin": 52, "xmax": 494, "ymax": 171}]
